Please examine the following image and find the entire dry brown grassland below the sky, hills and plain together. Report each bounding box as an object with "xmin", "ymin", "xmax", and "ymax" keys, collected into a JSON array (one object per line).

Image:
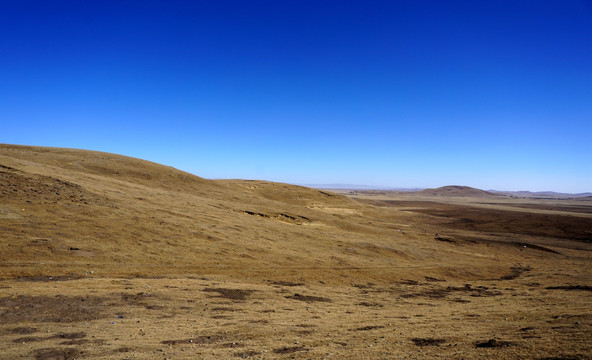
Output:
[{"xmin": 0, "ymin": 145, "xmax": 592, "ymax": 359}]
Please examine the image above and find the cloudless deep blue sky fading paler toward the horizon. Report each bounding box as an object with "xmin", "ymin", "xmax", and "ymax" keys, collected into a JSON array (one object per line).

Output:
[{"xmin": 0, "ymin": 0, "xmax": 592, "ymax": 192}]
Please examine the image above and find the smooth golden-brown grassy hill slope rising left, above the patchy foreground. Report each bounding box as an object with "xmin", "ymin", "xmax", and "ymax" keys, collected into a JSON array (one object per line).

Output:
[{"xmin": 0, "ymin": 145, "xmax": 532, "ymax": 281}]
